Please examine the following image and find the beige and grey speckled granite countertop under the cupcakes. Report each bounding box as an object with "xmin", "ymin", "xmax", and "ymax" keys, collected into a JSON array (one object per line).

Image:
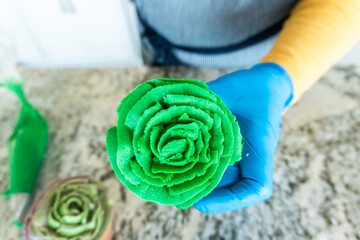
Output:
[{"xmin": 0, "ymin": 66, "xmax": 360, "ymax": 240}]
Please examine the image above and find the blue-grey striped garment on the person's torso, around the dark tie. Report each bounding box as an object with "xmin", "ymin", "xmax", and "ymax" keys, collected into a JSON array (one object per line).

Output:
[{"xmin": 135, "ymin": 0, "xmax": 297, "ymax": 67}]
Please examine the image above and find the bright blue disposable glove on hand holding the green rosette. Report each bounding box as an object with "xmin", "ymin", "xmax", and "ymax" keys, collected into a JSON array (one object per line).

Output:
[{"xmin": 194, "ymin": 63, "xmax": 294, "ymax": 213}]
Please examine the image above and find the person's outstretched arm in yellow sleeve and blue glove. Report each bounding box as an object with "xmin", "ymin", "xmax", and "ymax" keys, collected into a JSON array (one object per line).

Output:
[{"xmin": 194, "ymin": 0, "xmax": 360, "ymax": 213}]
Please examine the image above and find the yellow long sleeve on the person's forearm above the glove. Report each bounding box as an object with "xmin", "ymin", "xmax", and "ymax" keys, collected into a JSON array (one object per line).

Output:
[{"xmin": 261, "ymin": 0, "xmax": 360, "ymax": 99}]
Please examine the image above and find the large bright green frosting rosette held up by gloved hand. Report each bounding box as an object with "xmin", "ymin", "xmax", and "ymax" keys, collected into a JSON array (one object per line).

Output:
[{"xmin": 106, "ymin": 79, "xmax": 243, "ymax": 209}]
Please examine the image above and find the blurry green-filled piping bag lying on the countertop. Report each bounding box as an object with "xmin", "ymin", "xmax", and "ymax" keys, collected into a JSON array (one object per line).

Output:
[{"xmin": 0, "ymin": 78, "xmax": 48, "ymax": 227}]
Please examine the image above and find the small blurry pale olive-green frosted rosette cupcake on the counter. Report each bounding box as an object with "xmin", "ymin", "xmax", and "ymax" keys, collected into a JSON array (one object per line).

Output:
[{"xmin": 23, "ymin": 176, "xmax": 113, "ymax": 240}]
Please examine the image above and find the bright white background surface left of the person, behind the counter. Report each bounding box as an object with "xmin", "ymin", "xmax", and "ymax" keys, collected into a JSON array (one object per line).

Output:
[{"xmin": 0, "ymin": 0, "xmax": 142, "ymax": 67}]
